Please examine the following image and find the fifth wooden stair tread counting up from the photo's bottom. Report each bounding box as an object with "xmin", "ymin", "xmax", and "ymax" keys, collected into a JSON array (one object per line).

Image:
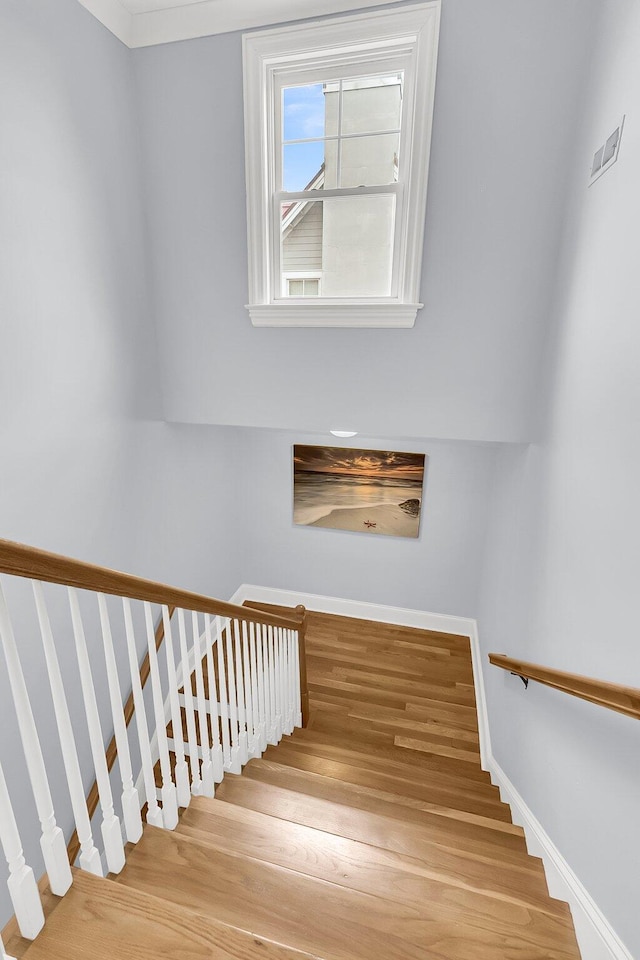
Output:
[{"xmin": 263, "ymin": 740, "xmax": 511, "ymax": 823}]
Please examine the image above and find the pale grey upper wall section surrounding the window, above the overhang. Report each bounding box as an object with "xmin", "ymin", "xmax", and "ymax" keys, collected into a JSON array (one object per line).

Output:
[{"xmin": 134, "ymin": 0, "xmax": 595, "ymax": 440}]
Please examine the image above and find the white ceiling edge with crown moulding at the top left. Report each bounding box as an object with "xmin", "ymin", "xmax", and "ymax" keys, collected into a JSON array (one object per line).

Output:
[{"xmin": 78, "ymin": 0, "xmax": 398, "ymax": 47}]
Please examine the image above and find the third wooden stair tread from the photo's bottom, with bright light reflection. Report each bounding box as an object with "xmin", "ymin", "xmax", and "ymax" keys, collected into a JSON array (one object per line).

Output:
[{"xmin": 178, "ymin": 798, "xmax": 568, "ymax": 918}]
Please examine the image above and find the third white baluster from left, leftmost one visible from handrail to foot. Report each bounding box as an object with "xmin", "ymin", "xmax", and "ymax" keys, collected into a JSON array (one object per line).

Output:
[{"xmin": 31, "ymin": 580, "xmax": 104, "ymax": 877}]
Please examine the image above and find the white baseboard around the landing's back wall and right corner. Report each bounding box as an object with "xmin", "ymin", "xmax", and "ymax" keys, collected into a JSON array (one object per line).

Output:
[{"xmin": 230, "ymin": 583, "xmax": 491, "ymax": 770}]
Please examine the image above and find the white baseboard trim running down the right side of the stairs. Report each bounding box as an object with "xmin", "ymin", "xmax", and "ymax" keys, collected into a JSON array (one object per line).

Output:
[{"xmin": 489, "ymin": 757, "xmax": 633, "ymax": 960}]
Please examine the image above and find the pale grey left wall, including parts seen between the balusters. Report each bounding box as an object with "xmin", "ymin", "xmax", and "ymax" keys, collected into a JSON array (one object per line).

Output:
[{"xmin": 0, "ymin": 0, "xmax": 239, "ymax": 927}]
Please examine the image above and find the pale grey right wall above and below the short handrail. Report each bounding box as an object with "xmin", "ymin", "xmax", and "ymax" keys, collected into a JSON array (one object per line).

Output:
[{"xmin": 480, "ymin": 0, "xmax": 640, "ymax": 957}]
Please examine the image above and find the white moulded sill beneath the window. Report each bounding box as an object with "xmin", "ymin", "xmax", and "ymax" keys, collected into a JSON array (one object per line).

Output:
[{"xmin": 247, "ymin": 301, "xmax": 423, "ymax": 329}]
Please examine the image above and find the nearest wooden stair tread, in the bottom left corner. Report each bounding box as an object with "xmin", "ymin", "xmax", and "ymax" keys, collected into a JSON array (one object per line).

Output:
[{"xmin": 23, "ymin": 870, "xmax": 311, "ymax": 960}]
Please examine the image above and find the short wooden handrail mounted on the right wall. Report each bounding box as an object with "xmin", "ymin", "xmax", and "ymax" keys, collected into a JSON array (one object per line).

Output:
[{"xmin": 489, "ymin": 653, "xmax": 640, "ymax": 720}]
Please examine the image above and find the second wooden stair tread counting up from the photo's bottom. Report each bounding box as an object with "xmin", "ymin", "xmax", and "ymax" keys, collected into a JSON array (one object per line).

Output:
[{"xmin": 118, "ymin": 827, "xmax": 574, "ymax": 960}]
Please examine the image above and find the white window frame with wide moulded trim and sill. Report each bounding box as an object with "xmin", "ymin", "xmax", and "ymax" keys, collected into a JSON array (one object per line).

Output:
[{"xmin": 243, "ymin": 0, "xmax": 440, "ymax": 327}]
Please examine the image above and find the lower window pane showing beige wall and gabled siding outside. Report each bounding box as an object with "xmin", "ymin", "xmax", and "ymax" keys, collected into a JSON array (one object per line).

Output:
[{"xmin": 281, "ymin": 195, "xmax": 395, "ymax": 297}]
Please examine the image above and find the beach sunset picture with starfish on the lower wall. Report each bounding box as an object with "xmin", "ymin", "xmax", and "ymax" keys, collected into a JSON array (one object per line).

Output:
[{"xmin": 293, "ymin": 444, "xmax": 426, "ymax": 537}]
